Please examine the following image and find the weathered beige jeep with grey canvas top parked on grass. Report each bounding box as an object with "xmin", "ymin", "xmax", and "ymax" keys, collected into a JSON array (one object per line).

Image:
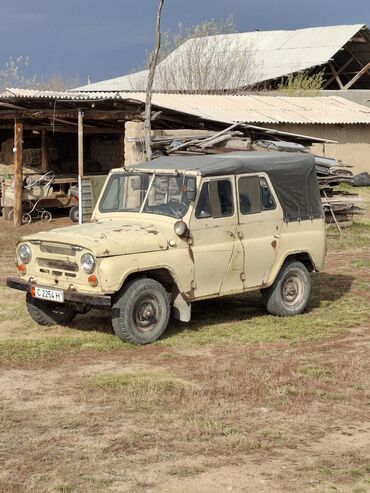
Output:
[{"xmin": 7, "ymin": 152, "xmax": 326, "ymax": 344}]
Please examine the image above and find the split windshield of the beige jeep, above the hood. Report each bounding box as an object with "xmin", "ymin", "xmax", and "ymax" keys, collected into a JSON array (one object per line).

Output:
[{"xmin": 99, "ymin": 173, "xmax": 190, "ymax": 218}]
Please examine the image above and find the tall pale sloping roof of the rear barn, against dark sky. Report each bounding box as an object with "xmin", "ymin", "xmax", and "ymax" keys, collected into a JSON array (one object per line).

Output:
[{"xmin": 77, "ymin": 24, "xmax": 365, "ymax": 91}]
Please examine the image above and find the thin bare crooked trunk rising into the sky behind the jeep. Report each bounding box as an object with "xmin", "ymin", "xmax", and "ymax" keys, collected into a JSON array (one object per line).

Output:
[{"xmin": 144, "ymin": 0, "xmax": 164, "ymax": 161}]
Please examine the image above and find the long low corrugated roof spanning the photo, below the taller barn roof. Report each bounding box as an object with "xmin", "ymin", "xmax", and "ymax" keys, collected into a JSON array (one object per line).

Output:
[{"xmin": 0, "ymin": 89, "xmax": 370, "ymax": 125}]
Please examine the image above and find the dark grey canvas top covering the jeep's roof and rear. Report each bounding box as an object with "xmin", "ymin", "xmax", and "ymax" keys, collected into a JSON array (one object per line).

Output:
[{"xmin": 134, "ymin": 151, "xmax": 323, "ymax": 221}]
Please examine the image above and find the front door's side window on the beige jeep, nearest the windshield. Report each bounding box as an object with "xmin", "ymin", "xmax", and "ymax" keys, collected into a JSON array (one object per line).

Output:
[{"xmin": 195, "ymin": 180, "xmax": 234, "ymax": 219}]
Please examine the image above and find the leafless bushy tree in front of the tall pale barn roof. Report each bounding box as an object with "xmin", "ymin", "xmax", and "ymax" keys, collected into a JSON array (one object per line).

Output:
[{"xmin": 131, "ymin": 16, "xmax": 257, "ymax": 93}]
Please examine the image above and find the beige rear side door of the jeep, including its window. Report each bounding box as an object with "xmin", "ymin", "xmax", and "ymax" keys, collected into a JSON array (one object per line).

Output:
[{"xmin": 237, "ymin": 173, "xmax": 283, "ymax": 289}]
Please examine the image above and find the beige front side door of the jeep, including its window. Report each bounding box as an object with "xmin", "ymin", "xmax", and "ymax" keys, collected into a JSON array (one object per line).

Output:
[{"xmin": 190, "ymin": 177, "xmax": 243, "ymax": 298}]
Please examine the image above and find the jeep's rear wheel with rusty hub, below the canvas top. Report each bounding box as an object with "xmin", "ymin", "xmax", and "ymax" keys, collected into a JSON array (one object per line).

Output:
[{"xmin": 261, "ymin": 260, "xmax": 311, "ymax": 317}]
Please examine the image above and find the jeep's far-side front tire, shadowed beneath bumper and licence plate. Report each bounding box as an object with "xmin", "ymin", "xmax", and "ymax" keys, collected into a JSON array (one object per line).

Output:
[{"xmin": 26, "ymin": 293, "xmax": 77, "ymax": 325}]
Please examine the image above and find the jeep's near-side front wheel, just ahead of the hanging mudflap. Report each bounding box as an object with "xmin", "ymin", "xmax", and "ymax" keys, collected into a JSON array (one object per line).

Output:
[{"xmin": 112, "ymin": 278, "xmax": 171, "ymax": 344}]
